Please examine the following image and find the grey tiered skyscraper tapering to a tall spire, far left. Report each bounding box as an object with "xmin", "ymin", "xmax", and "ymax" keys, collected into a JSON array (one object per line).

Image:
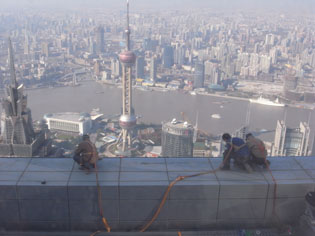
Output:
[{"xmin": 0, "ymin": 39, "xmax": 48, "ymax": 157}]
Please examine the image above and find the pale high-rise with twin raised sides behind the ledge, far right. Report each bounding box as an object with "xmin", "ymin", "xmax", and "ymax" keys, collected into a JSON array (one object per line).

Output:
[{"xmin": 272, "ymin": 120, "xmax": 310, "ymax": 156}]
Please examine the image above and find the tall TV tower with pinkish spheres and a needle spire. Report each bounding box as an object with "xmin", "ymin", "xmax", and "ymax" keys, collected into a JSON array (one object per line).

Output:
[{"xmin": 116, "ymin": 0, "xmax": 137, "ymax": 156}]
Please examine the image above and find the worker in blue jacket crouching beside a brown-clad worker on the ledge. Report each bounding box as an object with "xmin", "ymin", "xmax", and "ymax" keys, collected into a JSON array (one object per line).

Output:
[{"xmin": 221, "ymin": 133, "xmax": 253, "ymax": 173}]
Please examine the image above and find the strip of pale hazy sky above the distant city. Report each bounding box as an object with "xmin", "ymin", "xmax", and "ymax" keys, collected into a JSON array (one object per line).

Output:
[{"xmin": 0, "ymin": 0, "xmax": 315, "ymax": 11}]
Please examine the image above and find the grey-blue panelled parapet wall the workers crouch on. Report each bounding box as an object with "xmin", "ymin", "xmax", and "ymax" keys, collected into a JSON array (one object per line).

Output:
[{"xmin": 0, "ymin": 157, "xmax": 315, "ymax": 231}]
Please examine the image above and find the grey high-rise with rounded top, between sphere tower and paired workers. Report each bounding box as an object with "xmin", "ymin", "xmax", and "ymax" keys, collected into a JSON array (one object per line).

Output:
[{"xmin": 162, "ymin": 119, "xmax": 194, "ymax": 157}]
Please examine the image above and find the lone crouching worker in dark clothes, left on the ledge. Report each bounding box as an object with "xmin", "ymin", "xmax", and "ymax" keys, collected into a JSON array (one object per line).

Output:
[{"xmin": 73, "ymin": 134, "xmax": 98, "ymax": 170}]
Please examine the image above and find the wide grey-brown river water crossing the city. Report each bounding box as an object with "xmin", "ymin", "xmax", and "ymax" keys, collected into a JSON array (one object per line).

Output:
[{"xmin": 0, "ymin": 81, "xmax": 315, "ymax": 141}]
